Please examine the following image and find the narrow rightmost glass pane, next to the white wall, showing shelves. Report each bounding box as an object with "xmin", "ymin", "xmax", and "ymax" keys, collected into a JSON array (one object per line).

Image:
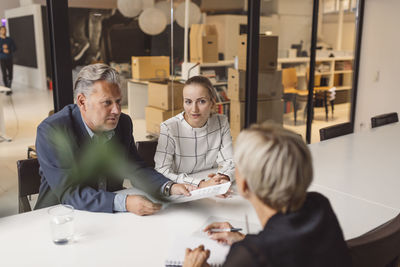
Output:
[{"xmin": 311, "ymin": 0, "xmax": 358, "ymax": 143}]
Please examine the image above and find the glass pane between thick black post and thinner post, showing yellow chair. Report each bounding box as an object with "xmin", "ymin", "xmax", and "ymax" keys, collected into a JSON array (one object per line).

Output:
[{"xmin": 258, "ymin": 0, "xmax": 313, "ymax": 141}]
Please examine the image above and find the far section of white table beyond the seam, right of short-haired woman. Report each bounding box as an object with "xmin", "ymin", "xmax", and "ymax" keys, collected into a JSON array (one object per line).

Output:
[{"xmin": 309, "ymin": 123, "xmax": 400, "ymax": 210}]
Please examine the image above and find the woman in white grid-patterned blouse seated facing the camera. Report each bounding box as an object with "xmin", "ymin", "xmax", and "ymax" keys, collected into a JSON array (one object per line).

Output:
[{"xmin": 154, "ymin": 76, "xmax": 235, "ymax": 191}]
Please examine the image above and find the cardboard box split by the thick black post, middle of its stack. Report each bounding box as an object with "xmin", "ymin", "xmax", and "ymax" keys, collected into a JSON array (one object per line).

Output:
[{"xmin": 228, "ymin": 68, "xmax": 283, "ymax": 101}]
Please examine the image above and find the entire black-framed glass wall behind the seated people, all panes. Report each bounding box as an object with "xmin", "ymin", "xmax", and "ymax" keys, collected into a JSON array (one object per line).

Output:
[{"xmin": 60, "ymin": 0, "xmax": 358, "ymax": 143}]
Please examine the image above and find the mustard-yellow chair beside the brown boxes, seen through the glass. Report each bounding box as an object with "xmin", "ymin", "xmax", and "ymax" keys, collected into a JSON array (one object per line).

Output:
[{"xmin": 282, "ymin": 68, "xmax": 308, "ymax": 125}]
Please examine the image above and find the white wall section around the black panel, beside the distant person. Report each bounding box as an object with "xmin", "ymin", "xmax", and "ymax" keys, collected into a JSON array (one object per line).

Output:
[{"xmin": 5, "ymin": 4, "xmax": 47, "ymax": 90}]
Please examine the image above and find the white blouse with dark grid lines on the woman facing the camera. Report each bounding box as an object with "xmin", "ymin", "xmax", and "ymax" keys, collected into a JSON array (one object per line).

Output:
[{"xmin": 154, "ymin": 112, "xmax": 235, "ymax": 185}]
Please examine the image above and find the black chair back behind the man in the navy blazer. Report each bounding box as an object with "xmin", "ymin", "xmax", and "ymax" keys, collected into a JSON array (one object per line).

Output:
[{"xmin": 17, "ymin": 158, "xmax": 41, "ymax": 213}]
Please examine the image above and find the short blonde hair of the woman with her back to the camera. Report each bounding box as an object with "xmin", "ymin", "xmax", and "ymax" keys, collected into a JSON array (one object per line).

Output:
[{"xmin": 235, "ymin": 123, "xmax": 313, "ymax": 213}]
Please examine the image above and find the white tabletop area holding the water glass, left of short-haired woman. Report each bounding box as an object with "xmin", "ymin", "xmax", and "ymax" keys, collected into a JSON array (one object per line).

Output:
[{"xmin": 0, "ymin": 186, "xmax": 260, "ymax": 267}]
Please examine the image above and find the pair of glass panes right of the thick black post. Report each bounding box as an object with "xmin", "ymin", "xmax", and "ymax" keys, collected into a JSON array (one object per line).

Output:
[{"xmin": 253, "ymin": 0, "xmax": 358, "ymax": 143}]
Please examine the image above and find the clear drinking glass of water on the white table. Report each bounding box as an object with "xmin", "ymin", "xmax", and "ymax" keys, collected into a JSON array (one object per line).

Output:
[{"xmin": 48, "ymin": 205, "xmax": 74, "ymax": 245}]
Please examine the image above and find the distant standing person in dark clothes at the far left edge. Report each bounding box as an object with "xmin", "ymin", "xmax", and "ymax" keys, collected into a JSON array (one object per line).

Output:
[{"xmin": 0, "ymin": 26, "xmax": 16, "ymax": 95}]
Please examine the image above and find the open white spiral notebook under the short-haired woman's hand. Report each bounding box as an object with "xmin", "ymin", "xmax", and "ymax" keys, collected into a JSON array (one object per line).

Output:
[{"xmin": 165, "ymin": 236, "xmax": 230, "ymax": 266}]
